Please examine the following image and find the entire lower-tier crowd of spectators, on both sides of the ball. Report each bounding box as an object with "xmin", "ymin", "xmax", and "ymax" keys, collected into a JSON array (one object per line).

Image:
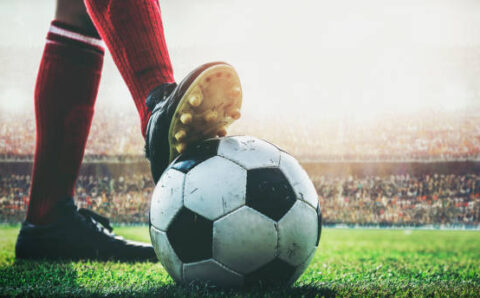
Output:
[{"xmin": 0, "ymin": 174, "xmax": 480, "ymax": 226}]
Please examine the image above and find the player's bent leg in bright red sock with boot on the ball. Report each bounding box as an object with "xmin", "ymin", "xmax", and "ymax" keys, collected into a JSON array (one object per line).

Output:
[{"xmin": 85, "ymin": 0, "xmax": 241, "ymax": 182}]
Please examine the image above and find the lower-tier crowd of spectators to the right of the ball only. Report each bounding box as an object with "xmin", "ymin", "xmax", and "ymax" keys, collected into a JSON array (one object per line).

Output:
[{"xmin": 313, "ymin": 174, "xmax": 480, "ymax": 226}]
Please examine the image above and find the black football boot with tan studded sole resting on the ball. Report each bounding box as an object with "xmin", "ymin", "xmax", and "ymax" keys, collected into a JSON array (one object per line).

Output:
[{"xmin": 145, "ymin": 62, "xmax": 242, "ymax": 183}]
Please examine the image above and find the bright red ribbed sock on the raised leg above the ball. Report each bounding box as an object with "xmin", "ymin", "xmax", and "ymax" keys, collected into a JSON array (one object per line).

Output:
[{"xmin": 85, "ymin": 0, "xmax": 174, "ymax": 136}]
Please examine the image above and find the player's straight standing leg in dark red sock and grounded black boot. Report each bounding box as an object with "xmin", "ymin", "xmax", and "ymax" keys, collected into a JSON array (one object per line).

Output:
[{"xmin": 16, "ymin": 0, "xmax": 155, "ymax": 260}]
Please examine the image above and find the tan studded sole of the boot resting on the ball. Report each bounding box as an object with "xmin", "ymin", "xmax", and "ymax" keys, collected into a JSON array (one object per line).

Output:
[{"xmin": 168, "ymin": 64, "xmax": 242, "ymax": 162}]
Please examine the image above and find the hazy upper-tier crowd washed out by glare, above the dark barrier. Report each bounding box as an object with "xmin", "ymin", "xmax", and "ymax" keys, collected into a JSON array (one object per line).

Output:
[{"xmin": 0, "ymin": 109, "xmax": 480, "ymax": 162}]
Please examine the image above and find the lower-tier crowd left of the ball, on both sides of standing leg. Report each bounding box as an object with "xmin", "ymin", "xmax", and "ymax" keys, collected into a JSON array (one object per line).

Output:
[{"xmin": 0, "ymin": 174, "xmax": 154, "ymax": 223}]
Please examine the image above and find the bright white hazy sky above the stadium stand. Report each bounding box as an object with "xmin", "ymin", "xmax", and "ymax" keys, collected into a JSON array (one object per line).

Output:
[{"xmin": 0, "ymin": 0, "xmax": 480, "ymax": 121}]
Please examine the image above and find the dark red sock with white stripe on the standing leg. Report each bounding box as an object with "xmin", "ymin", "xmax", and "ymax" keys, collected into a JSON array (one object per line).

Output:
[{"xmin": 27, "ymin": 21, "xmax": 104, "ymax": 224}]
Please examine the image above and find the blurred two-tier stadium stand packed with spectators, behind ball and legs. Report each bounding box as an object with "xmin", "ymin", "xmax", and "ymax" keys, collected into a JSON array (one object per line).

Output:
[{"xmin": 0, "ymin": 110, "xmax": 480, "ymax": 226}]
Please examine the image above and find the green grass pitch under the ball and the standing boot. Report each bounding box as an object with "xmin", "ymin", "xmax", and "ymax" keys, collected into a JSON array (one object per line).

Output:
[{"xmin": 0, "ymin": 225, "xmax": 480, "ymax": 297}]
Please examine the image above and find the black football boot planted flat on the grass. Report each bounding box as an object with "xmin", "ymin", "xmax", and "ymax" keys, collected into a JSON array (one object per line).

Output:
[{"xmin": 15, "ymin": 198, "xmax": 157, "ymax": 262}]
